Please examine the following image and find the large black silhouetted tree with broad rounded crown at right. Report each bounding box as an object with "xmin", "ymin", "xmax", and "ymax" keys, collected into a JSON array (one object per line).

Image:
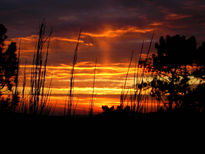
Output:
[{"xmin": 149, "ymin": 35, "xmax": 197, "ymax": 111}]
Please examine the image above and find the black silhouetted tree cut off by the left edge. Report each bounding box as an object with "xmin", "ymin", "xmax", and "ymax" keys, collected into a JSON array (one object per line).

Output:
[{"xmin": 0, "ymin": 24, "xmax": 18, "ymax": 110}]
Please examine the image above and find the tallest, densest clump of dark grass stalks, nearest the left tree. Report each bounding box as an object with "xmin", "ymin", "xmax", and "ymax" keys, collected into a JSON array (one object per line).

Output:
[{"xmin": 29, "ymin": 22, "xmax": 52, "ymax": 114}]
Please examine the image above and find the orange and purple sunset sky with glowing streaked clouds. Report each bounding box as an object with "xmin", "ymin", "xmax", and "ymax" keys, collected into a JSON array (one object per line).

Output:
[{"xmin": 0, "ymin": 0, "xmax": 205, "ymax": 114}]
